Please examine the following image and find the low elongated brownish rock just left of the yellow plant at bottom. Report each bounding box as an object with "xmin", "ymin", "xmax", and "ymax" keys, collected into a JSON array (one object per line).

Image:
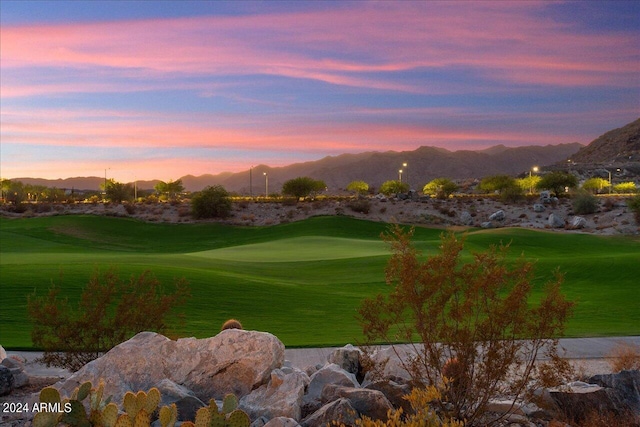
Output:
[{"xmin": 322, "ymin": 384, "xmax": 393, "ymax": 420}]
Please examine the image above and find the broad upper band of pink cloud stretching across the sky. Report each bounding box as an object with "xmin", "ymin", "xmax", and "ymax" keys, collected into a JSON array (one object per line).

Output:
[{"xmin": 0, "ymin": 2, "xmax": 640, "ymax": 96}]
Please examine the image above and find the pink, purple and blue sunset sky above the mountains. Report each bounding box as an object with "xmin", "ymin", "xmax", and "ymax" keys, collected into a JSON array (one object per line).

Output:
[{"xmin": 0, "ymin": 0, "xmax": 640, "ymax": 182}]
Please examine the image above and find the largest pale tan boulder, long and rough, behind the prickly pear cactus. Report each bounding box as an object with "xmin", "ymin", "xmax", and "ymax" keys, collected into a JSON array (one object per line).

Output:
[{"xmin": 59, "ymin": 329, "xmax": 284, "ymax": 402}]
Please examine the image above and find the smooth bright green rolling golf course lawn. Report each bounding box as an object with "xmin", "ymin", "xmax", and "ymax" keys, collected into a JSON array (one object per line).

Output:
[{"xmin": 0, "ymin": 216, "xmax": 640, "ymax": 348}]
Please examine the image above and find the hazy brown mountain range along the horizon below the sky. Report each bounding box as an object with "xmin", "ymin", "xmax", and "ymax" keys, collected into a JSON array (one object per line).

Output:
[{"xmin": 15, "ymin": 119, "xmax": 640, "ymax": 195}]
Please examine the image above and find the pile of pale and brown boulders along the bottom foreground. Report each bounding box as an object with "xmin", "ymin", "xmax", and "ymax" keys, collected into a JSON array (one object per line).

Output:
[{"xmin": 6, "ymin": 329, "xmax": 640, "ymax": 427}]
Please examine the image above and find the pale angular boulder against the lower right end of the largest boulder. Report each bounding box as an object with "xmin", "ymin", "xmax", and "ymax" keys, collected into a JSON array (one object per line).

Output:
[{"xmin": 240, "ymin": 369, "xmax": 309, "ymax": 421}]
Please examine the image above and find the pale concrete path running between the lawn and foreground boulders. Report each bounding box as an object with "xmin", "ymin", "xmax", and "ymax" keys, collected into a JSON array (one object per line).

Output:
[{"xmin": 7, "ymin": 336, "xmax": 640, "ymax": 378}]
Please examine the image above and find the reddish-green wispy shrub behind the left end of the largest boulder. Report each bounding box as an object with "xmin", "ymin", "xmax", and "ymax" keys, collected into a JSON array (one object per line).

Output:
[{"xmin": 27, "ymin": 269, "xmax": 190, "ymax": 371}]
